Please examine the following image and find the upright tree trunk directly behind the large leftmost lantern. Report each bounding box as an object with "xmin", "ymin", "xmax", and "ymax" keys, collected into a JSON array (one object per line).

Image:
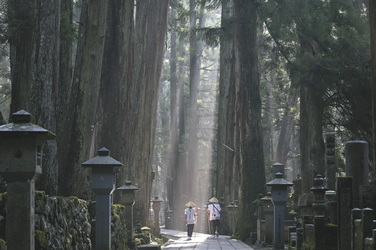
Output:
[{"xmin": 29, "ymin": 0, "xmax": 60, "ymax": 195}]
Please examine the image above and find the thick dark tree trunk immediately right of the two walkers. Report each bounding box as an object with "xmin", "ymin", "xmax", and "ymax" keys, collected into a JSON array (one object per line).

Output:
[{"xmin": 234, "ymin": 0, "xmax": 265, "ymax": 239}]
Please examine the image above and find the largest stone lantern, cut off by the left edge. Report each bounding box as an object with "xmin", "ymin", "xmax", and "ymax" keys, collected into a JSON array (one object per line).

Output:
[{"xmin": 0, "ymin": 110, "xmax": 55, "ymax": 249}]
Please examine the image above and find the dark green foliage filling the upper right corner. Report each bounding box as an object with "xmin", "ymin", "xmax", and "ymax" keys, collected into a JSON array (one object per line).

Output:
[{"xmin": 259, "ymin": 0, "xmax": 372, "ymax": 154}]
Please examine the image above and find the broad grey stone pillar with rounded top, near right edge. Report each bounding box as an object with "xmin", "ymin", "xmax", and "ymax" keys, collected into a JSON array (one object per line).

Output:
[{"xmin": 345, "ymin": 141, "xmax": 369, "ymax": 207}]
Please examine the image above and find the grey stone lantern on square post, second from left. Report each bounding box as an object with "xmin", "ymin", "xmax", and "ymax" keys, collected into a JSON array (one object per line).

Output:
[{"xmin": 82, "ymin": 148, "xmax": 123, "ymax": 250}]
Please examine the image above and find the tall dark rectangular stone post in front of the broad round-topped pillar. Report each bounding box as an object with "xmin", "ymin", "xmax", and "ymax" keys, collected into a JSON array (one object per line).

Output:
[{"xmin": 337, "ymin": 177, "xmax": 353, "ymax": 250}]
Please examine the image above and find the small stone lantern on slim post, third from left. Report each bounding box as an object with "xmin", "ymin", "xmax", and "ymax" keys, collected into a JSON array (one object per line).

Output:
[{"xmin": 116, "ymin": 181, "xmax": 139, "ymax": 243}]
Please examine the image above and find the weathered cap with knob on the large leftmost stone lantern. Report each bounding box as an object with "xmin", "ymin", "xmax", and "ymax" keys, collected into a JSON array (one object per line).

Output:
[{"xmin": 0, "ymin": 110, "xmax": 56, "ymax": 140}]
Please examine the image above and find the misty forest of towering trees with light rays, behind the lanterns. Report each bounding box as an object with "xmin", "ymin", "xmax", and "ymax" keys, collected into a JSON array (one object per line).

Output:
[{"xmin": 0, "ymin": 0, "xmax": 376, "ymax": 243}]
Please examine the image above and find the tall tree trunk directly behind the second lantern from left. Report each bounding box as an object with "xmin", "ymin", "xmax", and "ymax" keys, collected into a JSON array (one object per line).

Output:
[{"xmin": 95, "ymin": 0, "xmax": 134, "ymax": 197}]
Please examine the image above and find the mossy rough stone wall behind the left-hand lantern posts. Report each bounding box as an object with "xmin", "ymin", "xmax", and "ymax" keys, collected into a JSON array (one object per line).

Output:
[{"xmin": 0, "ymin": 191, "xmax": 129, "ymax": 250}]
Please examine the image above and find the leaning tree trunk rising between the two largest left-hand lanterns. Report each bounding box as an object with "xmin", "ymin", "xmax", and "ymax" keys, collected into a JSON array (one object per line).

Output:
[{"xmin": 59, "ymin": 0, "xmax": 108, "ymax": 198}]
